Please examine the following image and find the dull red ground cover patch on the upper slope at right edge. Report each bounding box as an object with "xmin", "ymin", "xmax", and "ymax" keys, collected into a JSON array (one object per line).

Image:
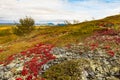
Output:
[{"xmin": 85, "ymin": 28, "xmax": 120, "ymax": 57}]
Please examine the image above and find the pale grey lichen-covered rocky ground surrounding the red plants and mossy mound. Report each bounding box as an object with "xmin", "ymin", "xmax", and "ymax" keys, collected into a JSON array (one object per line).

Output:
[{"xmin": 0, "ymin": 43, "xmax": 120, "ymax": 80}]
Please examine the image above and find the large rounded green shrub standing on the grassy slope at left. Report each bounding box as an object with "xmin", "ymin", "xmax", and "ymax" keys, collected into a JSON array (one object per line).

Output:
[{"xmin": 13, "ymin": 17, "xmax": 35, "ymax": 35}]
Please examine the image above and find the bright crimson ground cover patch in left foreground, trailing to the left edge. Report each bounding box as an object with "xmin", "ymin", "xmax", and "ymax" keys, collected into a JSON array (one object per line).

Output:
[{"xmin": 0, "ymin": 43, "xmax": 56, "ymax": 80}]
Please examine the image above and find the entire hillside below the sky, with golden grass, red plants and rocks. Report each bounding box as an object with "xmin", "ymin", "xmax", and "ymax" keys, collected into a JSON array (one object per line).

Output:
[{"xmin": 0, "ymin": 15, "xmax": 120, "ymax": 80}]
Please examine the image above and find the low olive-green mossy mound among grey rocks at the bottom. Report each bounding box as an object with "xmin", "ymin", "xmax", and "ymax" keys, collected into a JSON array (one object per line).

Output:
[{"xmin": 43, "ymin": 59, "xmax": 89, "ymax": 80}]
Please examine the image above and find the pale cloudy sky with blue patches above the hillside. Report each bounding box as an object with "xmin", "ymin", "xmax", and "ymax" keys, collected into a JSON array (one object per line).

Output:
[{"xmin": 0, "ymin": 0, "xmax": 120, "ymax": 23}]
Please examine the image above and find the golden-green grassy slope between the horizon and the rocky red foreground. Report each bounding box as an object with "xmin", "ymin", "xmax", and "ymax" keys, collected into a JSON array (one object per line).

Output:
[{"xmin": 0, "ymin": 15, "xmax": 120, "ymax": 60}]
